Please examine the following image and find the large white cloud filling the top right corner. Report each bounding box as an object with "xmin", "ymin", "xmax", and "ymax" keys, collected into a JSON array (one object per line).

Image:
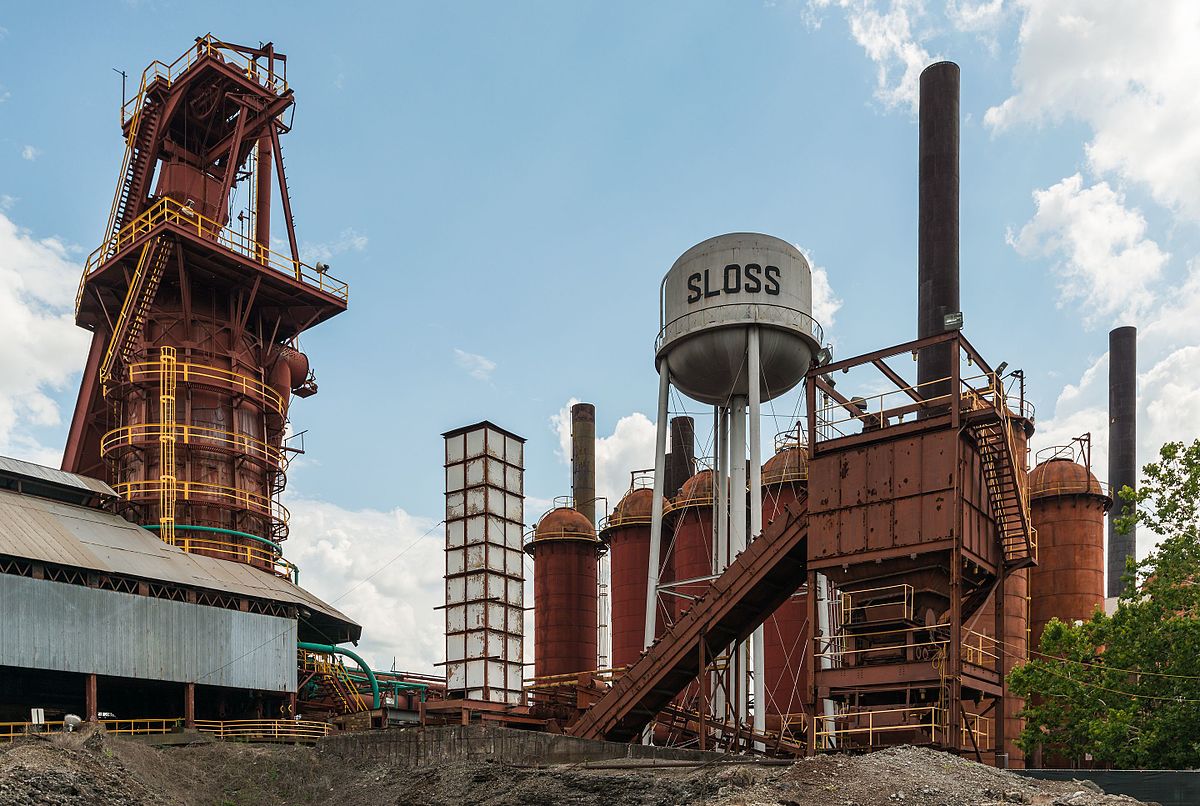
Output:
[{"xmin": 985, "ymin": 0, "xmax": 1200, "ymax": 219}]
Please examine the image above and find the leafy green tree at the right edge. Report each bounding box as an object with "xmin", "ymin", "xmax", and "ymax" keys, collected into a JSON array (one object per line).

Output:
[{"xmin": 1008, "ymin": 440, "xmax": 1200, "ymax": 769}]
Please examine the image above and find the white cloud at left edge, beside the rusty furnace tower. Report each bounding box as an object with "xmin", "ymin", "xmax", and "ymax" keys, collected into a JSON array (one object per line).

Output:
[{"xmin": 0, "ymin": 213, "xmax": 88, "ymax": 467}]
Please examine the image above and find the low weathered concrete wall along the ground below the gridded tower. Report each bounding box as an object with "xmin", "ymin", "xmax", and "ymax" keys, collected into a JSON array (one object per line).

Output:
[{"xmin": 318, "ymin": 724, "xmax": 722, "ymax": 768}]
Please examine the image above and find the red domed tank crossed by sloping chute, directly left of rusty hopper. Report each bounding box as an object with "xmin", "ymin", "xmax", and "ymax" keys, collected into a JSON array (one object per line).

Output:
[{"xmin": 762, "ymin": 439, "xmax": 809, "ymax": 730}]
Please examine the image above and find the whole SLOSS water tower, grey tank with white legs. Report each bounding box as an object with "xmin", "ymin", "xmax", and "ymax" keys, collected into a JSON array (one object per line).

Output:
[{"xmin": 644, "ymin": 233, "xmax": 822, "ymax": 730}]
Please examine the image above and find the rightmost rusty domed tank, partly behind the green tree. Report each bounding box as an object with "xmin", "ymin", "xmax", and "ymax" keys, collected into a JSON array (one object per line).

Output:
[{"xmin": 1030, "ymin": 457, "xmax": 1112, "ymax": 649}]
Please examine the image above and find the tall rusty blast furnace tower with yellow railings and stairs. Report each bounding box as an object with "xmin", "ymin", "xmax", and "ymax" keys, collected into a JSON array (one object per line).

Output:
[{"xmin": 62, "ymin": 36, "xmax": 348, "ymax": 576}]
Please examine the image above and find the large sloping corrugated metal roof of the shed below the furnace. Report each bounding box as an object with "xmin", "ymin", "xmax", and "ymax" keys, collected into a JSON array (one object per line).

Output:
[{"xmin": 0, "ymin": 484, "xmax": 361, "ymax": 643}]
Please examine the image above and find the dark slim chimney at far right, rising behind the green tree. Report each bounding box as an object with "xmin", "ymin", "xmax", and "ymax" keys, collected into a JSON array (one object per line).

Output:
[{"xmin": 1108, "ymin": 327, "xmax": 1138, "ymax": 596}]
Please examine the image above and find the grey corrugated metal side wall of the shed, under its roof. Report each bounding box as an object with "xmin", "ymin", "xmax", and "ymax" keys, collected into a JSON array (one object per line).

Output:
[{"xmin": 0, "ymin": 575, "xmax": 296, "ymax": 692}]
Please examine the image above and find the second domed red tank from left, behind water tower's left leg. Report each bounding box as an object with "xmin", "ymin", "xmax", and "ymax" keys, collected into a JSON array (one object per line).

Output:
[{"xmin": 600, "ymin": 487, "xmax": 666, "ymax": 668}]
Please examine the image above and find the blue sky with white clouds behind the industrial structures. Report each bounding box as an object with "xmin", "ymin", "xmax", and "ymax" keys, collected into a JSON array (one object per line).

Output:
[{"xmin": 0, "ymin": 0, "xmax": 1200, "ymax": 666}]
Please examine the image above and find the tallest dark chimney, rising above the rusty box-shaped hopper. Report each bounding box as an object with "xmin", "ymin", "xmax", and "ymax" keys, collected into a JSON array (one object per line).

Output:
[{"xmin": 917, "ymin": 61, "xmax": 961, "ymax": 397}]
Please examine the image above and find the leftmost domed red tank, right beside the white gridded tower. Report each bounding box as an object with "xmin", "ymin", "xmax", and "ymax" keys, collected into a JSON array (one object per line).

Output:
[{"xmin": 524, "ymin": 506, "xmax": 600, "ymax": 678}]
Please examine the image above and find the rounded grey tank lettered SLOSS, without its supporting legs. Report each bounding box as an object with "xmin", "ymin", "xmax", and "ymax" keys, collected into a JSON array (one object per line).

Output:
[{"xmin": 655, "ymin": 233, "xmax": 822, "ymax": 405}]
